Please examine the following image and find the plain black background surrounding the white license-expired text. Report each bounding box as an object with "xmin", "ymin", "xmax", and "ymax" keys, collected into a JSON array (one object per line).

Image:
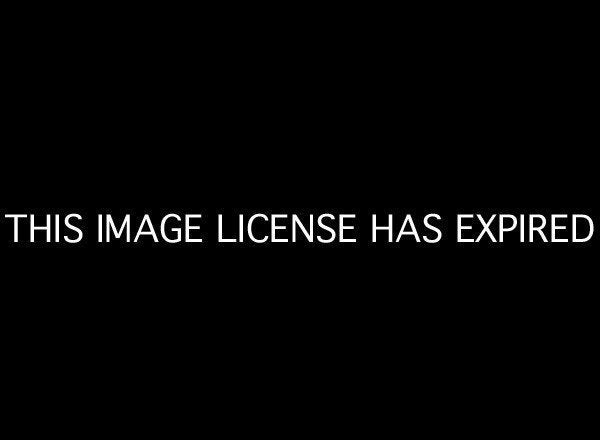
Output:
[{"xmin": 1, "ymin": 5, "xmax": 598, "ymax": 433}]
